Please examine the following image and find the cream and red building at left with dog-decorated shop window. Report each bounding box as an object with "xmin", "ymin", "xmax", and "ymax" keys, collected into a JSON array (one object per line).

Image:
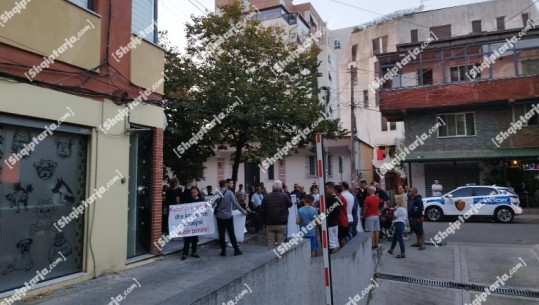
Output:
[{"xmin": 0, "ymin": 0, "xmax": 164, "ymax": 292}]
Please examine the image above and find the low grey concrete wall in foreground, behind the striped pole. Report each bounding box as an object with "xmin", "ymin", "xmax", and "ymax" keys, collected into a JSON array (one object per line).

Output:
[{"xmin": 188, "ymin": 233, "xmax": 374, "ymax": 305}]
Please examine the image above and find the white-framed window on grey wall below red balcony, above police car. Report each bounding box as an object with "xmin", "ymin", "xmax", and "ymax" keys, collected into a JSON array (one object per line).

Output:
[{"xmin": 438, "ymin": 112, "xmax": 475, "ymax": 138}]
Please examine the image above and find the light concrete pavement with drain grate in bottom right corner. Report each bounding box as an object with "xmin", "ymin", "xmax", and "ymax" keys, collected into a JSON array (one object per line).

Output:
[{"xmin": 369, "ymin": 240, "xmax": 539, "ymax": 305}]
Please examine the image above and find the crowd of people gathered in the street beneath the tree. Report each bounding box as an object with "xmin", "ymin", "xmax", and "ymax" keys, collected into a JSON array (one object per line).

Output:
[{"xmin": 163, "ymin": 179, "xmax": 426, "ymax": 260}]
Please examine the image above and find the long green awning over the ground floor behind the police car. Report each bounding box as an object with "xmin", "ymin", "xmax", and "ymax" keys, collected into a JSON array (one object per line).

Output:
[{"xmin": 404, "ymin": 147, "xmax": 539, "ymax": 162}]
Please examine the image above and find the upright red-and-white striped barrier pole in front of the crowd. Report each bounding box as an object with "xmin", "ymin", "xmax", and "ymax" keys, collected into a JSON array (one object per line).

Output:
[{"xmin": 316, "ymin": 133, "xmax": 333, "ymax": 305}]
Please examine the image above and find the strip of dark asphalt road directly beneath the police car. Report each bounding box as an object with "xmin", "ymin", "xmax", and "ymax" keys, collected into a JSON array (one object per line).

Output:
[{"xmin": 424, "ymin": 214, "xmax": 539, "ymax": 245}]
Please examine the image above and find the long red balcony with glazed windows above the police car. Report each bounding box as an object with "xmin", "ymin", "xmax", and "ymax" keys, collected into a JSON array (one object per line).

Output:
[{"xmin": 378, "ymin": 35, "xmax": 539, "ymax": 121}]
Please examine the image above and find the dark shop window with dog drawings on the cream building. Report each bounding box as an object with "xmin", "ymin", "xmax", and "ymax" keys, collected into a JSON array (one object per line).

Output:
[{"xmin": 0, "ymin": 114, "xmax": 91, "ymax": 292}]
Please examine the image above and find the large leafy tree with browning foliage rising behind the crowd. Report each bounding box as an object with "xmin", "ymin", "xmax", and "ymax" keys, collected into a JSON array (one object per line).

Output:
[{"xmin": 167, "ymin": 1, "xmax": 345, "ymax": 186}]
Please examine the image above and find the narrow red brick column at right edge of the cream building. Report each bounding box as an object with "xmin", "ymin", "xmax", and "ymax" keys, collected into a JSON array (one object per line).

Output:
[{"xmin": 151, "ymin": 128, "xmax": 163, "ymax": 255}]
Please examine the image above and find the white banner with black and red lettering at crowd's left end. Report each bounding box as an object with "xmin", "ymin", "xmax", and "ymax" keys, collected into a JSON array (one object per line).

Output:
[{"xmin": 168, "ymin": 201, "xmax": 215, "ymax": 238}]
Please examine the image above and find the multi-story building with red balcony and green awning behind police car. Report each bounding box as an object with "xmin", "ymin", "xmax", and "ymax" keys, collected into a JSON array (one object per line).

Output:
[{"xmin": 378, "ymin": 1, "xmax": 539, "ymax": 196}]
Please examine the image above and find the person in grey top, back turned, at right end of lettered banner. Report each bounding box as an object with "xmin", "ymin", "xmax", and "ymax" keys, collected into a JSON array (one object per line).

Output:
[{"xmin": 215, "ymin": 179, "xmax": 247, "ymax": 256}]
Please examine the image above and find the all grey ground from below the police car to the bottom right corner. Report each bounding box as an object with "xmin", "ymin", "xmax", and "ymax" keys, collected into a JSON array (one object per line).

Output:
[{"xmin": 369, "ymin": 214, "xmax": 539, "ymax": 305}]
